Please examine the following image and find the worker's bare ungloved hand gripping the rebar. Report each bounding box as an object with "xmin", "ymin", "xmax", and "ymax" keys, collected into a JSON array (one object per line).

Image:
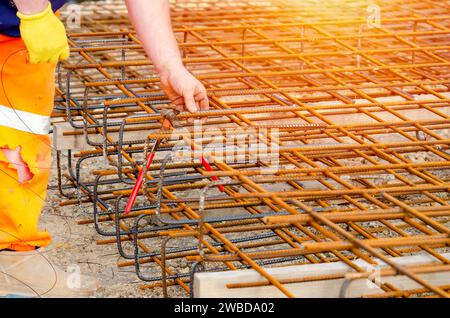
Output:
[{"xmin": 160, "ymin": 65, "xmax": 209, "ymax": 113}]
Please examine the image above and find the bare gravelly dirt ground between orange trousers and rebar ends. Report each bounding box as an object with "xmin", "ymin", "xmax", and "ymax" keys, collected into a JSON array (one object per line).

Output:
[{"xmin": 41, "ymin": 155, "xmax": 167, "ymax": 297}]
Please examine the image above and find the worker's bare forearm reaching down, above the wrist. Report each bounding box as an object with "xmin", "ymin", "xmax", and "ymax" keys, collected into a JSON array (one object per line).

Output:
[{"xmin": 126, "ymin": 0, "xmax": 182, "ymax": 74}]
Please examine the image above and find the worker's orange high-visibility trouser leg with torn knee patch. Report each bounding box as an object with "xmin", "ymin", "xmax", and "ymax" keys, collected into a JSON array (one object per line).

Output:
[{"xmin": 0, "ymin": 35, "xmax": 55, "ymax": 251}]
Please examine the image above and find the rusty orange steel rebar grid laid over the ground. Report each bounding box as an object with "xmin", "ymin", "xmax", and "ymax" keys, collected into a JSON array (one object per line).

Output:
[{"xmin": 54, "ymin": 0, "xmax": 450, "ymax": 297}]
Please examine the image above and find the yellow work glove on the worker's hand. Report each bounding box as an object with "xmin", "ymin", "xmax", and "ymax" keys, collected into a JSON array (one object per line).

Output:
[{"xmin": 17, "ymin": 3, "xmax": 70, "ymax": 64}]
